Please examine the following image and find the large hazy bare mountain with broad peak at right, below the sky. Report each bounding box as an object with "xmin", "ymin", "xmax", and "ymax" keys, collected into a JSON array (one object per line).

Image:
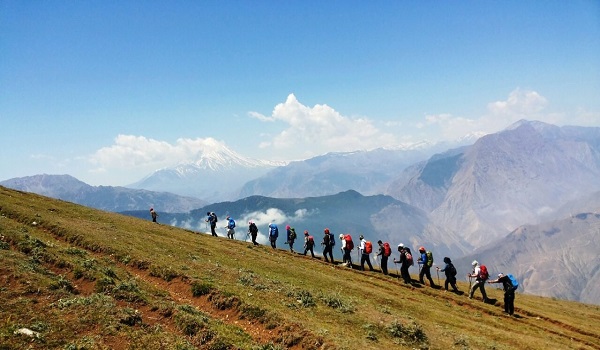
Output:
[{"xmin": 385, "ymin": 121, "xmax": 600, "ymax": 247}]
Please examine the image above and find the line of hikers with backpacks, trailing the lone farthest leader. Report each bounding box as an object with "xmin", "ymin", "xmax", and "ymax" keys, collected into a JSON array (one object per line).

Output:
[{"xmin": 200, "ymin": 212, "xmax": 519, "ymax": 315}]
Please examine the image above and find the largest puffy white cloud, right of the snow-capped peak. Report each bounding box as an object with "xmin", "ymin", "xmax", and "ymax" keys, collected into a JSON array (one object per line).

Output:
[{"xmin": 249, "ymin": 94, "xmax": 397, "ymax": 156}]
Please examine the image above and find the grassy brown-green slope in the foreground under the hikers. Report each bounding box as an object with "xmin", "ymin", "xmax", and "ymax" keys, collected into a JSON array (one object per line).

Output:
[{"xmin": 0, "ymin": 187, "xmax": 600, "ymax": 349}]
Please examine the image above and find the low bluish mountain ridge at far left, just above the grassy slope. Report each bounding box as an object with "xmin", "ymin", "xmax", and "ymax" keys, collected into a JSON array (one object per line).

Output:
[{"xmin": 0, "ymin": 175, "xmax": 206, "ymax": 215}]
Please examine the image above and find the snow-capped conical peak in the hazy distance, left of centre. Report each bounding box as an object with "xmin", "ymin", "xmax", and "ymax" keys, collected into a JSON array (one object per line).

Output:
[{"xmin": 127, "ymin": 138, "xmax": 285, "ymax": 201}]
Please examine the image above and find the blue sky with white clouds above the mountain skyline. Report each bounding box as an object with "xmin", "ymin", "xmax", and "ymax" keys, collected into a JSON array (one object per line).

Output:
[{"xmin": 0, "ymin": 0, "xmax": 600, "ymax": 185}]
